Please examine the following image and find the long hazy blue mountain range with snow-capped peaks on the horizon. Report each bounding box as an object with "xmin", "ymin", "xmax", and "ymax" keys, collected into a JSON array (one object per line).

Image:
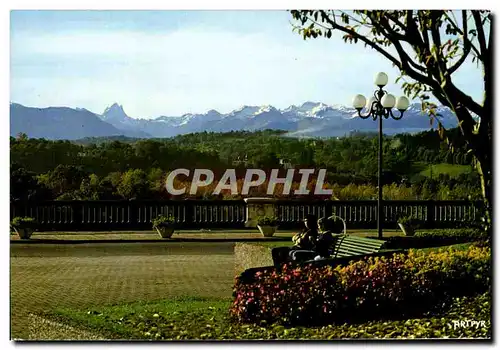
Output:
[{"xmin": 10, "ymin": 102, "xmax": 457, "ymax": 140}]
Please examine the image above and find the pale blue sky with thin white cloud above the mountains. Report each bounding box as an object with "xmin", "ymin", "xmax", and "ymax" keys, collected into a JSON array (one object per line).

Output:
[{"xmin": 10, "ymin": 11, "xmax": 482, "ymax": 118}]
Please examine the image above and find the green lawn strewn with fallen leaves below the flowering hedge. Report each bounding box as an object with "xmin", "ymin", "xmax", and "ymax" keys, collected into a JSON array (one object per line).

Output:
[{"xmin": 52, "ymin": 294, "xmax": 491, "ymax": 340}]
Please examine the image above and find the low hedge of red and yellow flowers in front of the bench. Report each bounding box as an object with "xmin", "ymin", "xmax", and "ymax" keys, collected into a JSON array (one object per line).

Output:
[{"xmin": 231, "ymin": 245, "xmax": 490, "ymax": 325}]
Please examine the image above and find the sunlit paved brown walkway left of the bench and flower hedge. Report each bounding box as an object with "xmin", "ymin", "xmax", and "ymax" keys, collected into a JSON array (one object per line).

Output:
[{"xmin": 10, "ymin": 242, "xmax": 234, "ymax": 339}]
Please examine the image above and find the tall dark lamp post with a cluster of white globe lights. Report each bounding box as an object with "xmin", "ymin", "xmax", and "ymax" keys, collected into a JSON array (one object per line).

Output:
[{"xmin": 352, "ymin": 72, "xmax": 410, "ymax": 238}]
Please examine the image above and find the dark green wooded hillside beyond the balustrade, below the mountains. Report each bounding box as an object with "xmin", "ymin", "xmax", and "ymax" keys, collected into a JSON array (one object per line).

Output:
[{"xmin": 11, "ymin": 130, "xmax": 481, "ymax": 200}]
